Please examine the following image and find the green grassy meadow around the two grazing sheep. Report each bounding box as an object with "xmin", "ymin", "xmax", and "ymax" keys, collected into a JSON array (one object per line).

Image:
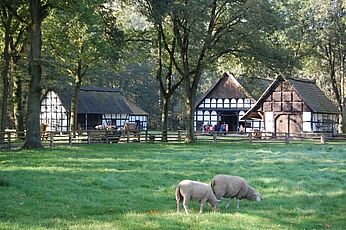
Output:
[{"xmin": 0, "ymin": 143, "xmax": 346, "ymax": 229}]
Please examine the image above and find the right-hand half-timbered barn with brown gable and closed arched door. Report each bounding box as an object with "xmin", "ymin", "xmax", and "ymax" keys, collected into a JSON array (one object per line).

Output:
[{"xmin": 241, "ymin": 76, "xmax": 340, "ymax": 133}]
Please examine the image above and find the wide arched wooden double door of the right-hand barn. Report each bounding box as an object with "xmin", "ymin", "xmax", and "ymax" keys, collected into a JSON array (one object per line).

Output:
[{"xmin": 275, "ymin": 114, "xmax": 303, "ymax": 133}]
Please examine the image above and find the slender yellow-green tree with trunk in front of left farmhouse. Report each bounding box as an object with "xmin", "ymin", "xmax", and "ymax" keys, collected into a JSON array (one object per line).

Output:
[{"xmin": 44, "ymin": 0, "xmax": 121, "ymax": 131}]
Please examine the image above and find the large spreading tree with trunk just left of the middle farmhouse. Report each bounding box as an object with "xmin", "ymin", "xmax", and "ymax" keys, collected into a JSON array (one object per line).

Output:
[{"xmin": 153, "ymin": 0, "xmax": 286, "ymax": 142}]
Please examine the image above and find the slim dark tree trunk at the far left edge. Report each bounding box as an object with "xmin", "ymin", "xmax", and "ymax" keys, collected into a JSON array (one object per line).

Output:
[{"xmin": 0, "ymin": 15, "xmax": 12, "ymax": 142}]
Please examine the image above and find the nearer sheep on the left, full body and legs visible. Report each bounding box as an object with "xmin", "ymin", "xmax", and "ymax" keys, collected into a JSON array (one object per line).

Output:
[{"xmin": 175, "ymin": 180, "xmax": 218, "ymax": 214}]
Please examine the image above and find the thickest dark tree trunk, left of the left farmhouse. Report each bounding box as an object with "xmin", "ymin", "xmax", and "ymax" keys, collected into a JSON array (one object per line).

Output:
[{"xmin": 24, "ymin": 0, "xmax": 43, "ymax": 148}]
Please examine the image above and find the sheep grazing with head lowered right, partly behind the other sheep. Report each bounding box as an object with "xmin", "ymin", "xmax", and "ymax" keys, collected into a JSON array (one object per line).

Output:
[{"xmin": 211, "ymin": 175, "xmax": 261, "ymax": 208}]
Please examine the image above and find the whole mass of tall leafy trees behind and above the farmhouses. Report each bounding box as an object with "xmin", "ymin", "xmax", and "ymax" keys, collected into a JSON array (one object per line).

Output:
[{"xmin": 0, "ymin": 0, "xmax": 346, "ymax": 147}]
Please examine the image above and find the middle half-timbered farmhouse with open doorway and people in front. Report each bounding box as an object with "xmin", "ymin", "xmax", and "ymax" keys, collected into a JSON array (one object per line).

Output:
[{"xmin": 194, "ymin": 73, "xmax": 261, "ymax": 132}]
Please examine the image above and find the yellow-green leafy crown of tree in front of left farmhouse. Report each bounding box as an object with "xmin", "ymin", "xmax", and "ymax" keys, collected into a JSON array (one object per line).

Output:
[{"xmin": 43, "ymin": 0, "xmax": 123, "ymax": 89}]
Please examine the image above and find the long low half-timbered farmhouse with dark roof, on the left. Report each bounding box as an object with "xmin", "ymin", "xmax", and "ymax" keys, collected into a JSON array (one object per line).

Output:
[{"xmin": 40, "ymin": 86, "xmax": 148, "ymax": 131}]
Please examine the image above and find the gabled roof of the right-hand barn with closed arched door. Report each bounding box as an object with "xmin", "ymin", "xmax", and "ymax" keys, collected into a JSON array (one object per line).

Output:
[{"xmin": 242, "ymin": 76, "xmax": 340, "ymax": 119}]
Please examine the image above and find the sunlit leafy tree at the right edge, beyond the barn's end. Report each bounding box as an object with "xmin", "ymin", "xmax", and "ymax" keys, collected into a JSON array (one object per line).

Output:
[{"xmin": 311, "ymin": 0, "xmax": 346, "ymax": 132}]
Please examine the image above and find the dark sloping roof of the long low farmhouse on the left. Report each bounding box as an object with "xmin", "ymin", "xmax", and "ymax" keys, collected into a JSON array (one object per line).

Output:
[{"xmin": 57, "ymin": 86, "xmax": 148, "ymax": 115}]
